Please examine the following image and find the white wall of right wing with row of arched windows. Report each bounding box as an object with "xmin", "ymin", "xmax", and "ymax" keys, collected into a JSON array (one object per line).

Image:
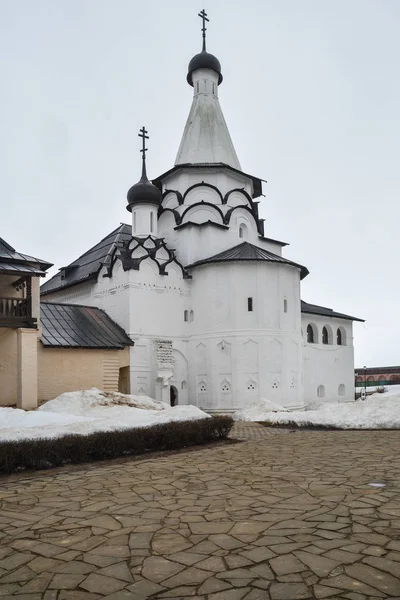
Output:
[{"xmin": 301, "ymin": 313, "xmax": 354, "ymax": 404}]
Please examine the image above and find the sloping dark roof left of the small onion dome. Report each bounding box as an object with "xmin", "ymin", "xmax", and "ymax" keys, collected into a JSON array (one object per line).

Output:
[{"xmin": 40, "ymin": 223, "xmax": 132, "ymax": 296}]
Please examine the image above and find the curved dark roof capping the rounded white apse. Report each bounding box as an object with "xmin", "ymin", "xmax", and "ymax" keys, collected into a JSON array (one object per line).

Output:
[{"xmin": 186, "ymin": 242, "xmax": 308, "ymax": 279}]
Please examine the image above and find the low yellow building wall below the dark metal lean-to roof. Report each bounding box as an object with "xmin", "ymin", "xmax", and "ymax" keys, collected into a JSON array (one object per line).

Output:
[{"xmin": 38, "ymin": 344, "xmax": 129, "ymax": 401}]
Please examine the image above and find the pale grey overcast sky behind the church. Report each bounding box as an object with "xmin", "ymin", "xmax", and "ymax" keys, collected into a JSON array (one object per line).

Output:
[{"xmin": 0, "ymin": 0, "xmax": 400, "ymax": 366}]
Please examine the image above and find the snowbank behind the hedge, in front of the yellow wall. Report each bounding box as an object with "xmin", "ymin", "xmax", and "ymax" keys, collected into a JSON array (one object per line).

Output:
[{"xmin": 0, "ymin": 388, "xmax": 210, "ymax": 441}]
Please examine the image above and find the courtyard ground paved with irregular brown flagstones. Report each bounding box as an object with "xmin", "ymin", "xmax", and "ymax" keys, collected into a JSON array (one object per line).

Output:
[{"xmin": 0, "ymin": 426, "xmax": 400, "ymax": 600}]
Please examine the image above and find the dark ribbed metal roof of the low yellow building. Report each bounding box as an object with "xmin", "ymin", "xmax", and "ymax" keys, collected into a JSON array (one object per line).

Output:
[{"xmin": 40, "ymin": 302, "xmax": 134, "ymax": 350}]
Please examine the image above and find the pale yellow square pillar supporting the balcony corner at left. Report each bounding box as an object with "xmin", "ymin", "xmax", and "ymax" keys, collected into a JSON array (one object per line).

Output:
[{"xmin": 17, "ymin": 328, "xmax": 38, "ymax": 410}]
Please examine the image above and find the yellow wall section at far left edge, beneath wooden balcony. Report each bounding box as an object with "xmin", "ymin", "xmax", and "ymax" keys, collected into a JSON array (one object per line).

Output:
[{"xmin": 0, "ymin": 327, "xmax": 18, "ymax": 406}]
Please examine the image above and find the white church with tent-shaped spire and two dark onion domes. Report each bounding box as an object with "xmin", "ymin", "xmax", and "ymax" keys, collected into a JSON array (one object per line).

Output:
[{"xmin": 41, "ymin": 10, "xmax": 361, "ymax": 412}]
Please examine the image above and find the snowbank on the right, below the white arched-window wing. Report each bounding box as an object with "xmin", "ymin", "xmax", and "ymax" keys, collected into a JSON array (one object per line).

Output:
[{"xmin": 233, "ymin": 385, "xmax": 400, "ymax": 429}]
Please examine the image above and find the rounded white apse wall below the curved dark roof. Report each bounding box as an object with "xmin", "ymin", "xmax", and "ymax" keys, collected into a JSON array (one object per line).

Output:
[{"xmin": 188, "ymin": 263, "xmax": 303, "ymax": 410}]
